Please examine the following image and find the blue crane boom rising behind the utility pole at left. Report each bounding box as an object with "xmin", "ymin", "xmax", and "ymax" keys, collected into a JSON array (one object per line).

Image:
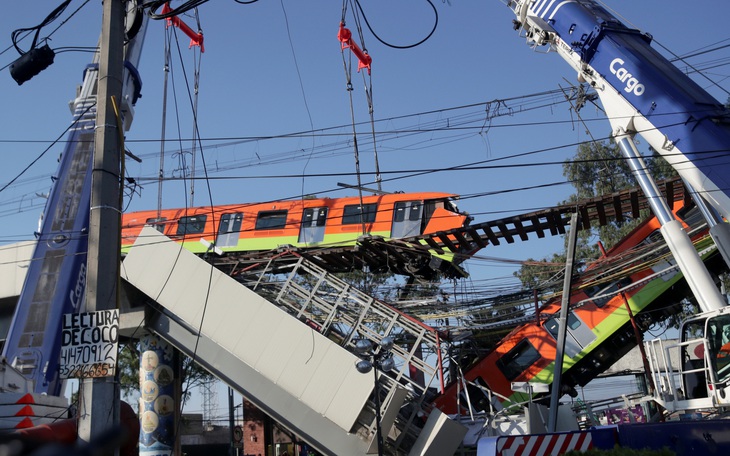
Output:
[{"xmin": 2, "ymin": 9, "xmax": 147, "ymax": 396}]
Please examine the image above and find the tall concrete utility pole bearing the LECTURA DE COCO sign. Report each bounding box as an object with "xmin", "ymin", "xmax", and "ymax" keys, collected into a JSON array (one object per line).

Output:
[{"xmin": 78, "ymin": 0, "xmax": 125, "ymax": 448}]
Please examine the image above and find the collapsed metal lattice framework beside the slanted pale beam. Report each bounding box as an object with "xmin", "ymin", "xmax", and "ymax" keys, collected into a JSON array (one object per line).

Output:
[{"xmin": 248, "ymin": 257, "xmax": 444, "ymax": 449}]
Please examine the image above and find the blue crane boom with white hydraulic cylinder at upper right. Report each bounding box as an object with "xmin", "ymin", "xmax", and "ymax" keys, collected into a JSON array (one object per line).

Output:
[{"xmin": 508, "ymin": 0, "xmax": 730, "ymax": 311}]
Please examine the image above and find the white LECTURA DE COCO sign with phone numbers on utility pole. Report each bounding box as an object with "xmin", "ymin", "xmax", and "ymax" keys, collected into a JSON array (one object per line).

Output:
[{"xmin": 60, "ymin": 309, "xmax": 119, "ymax": 378}]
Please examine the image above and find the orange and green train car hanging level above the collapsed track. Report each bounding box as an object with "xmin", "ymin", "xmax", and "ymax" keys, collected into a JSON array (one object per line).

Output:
[{"xmin": 122, "ymin": 192, "xmax": 470, "ymax": 261}]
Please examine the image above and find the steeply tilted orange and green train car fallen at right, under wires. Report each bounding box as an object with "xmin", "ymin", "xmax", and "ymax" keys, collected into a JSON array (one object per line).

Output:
[{"xmin": 434, "ymin": 202, "xmax": 719, "ymax": 414}]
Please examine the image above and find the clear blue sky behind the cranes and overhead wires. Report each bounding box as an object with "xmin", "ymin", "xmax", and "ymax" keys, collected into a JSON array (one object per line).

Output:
[{"xmin": 0, "ymin": 0, "xmax": 730, "ymax": 414}]
